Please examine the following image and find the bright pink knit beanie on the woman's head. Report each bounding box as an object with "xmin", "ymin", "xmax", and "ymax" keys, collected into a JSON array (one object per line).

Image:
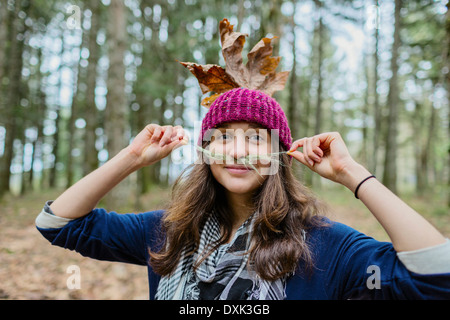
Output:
[{"xmin": 199, "ymin": 88, "xmax": 292, "ymax": 150}]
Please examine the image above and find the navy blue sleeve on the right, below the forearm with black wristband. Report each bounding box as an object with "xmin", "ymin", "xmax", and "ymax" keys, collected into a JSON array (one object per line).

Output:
[{"xmin": 322, "ymin": 223, "xmax": 450, "ymax": 299}]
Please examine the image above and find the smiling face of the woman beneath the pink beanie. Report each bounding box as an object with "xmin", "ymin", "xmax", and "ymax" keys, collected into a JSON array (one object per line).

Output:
[{"xmin": 209, "ymin": 122, "xmax": 271, "ymax": 194}]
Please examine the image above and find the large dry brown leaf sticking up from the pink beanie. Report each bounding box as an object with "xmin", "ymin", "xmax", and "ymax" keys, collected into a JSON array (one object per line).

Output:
[{"xmin": 180, "ymin": 19, "xmax": 289, "ymax": 107}]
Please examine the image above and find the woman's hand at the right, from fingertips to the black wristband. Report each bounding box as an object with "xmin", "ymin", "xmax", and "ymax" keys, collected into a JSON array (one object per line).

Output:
[{"xmin": 288, "ymin": 132, "xmax": 368, "ymax": 189}]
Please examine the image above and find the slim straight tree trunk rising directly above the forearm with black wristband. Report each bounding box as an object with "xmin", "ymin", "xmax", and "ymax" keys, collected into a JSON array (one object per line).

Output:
[{"xmin": 383, "ymin": 0, "xmax": 402, "ymax": 193}]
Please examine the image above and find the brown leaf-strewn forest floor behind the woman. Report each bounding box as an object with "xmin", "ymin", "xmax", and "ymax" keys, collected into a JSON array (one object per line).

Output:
[{"xmin": 0, "ymin": 188, "xmax": 450, "ymax": 300}]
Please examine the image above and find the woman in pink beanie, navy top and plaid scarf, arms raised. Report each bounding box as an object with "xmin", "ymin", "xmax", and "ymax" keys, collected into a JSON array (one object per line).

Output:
[{"xmin": 36, "ymin": 88, "xmax": 450, "ymax": 299}]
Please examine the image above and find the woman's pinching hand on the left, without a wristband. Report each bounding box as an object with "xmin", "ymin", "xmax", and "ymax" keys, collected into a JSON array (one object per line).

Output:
[{"xmin": 127, "ymin": 123, "xmax": 188, "ymax": 167}]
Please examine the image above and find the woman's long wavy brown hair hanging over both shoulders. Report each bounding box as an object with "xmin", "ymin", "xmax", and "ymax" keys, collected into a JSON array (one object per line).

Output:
[{"xmin": 150, "ymin": 149, "xmax": 325, "ymax": 280}]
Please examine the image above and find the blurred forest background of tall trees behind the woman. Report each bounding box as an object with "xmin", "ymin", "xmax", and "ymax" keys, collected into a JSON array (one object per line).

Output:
[{"xmin": 0, "ymin": 0, "xmax": 450, "ymax": 298}]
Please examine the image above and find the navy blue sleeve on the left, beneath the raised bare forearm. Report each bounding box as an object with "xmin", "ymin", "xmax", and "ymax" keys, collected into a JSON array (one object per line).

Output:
[{"xmin": 37, "ymin": 209, "xmax": 162, "ymax": 265}]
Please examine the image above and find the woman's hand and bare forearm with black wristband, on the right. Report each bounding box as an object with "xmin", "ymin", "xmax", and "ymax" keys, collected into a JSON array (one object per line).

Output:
[{"xmin": 288, "ymin": 132, "xmax": 446, "ymax": 252}]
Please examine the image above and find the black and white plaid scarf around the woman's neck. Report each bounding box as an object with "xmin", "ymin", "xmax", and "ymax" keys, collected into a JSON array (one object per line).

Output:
[{"xmin": 156, "ymin": 213, "xmax": 286, "ymax": 300}]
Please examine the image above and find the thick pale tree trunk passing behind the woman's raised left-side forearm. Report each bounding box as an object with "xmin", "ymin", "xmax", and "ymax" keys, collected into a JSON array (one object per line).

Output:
[{"xmin": 105, "ymin": 0, "xmax": 128, "ymax": 208}]
